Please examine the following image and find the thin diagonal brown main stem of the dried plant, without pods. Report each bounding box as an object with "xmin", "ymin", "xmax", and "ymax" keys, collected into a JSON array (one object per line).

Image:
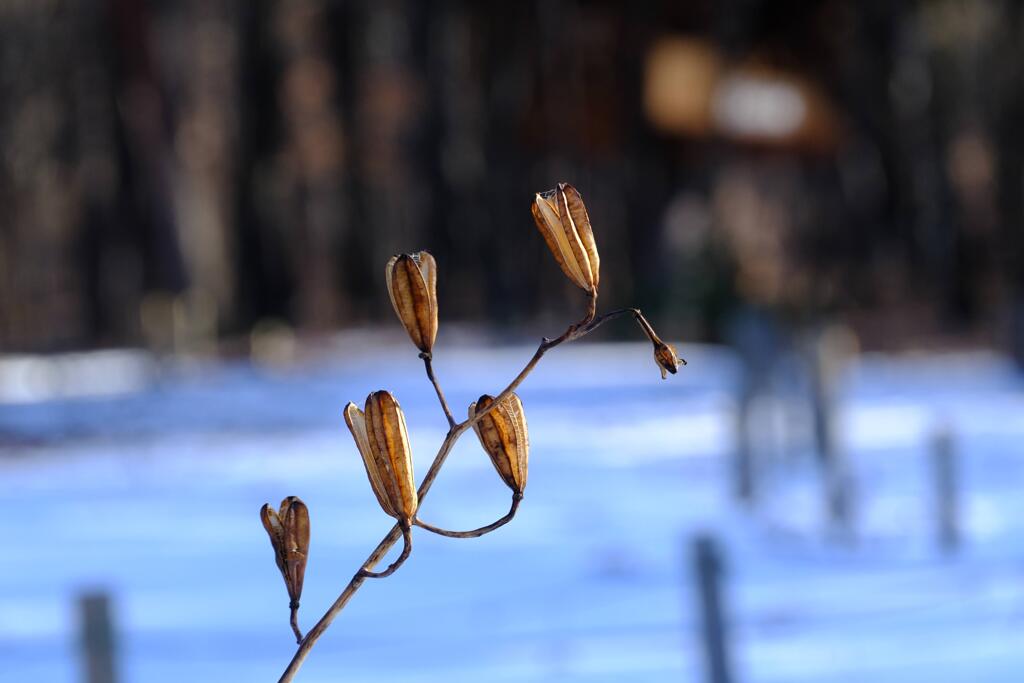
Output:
[{"xmin": 278, "ymin": 293, "xmax": 653, "ymax": 683}]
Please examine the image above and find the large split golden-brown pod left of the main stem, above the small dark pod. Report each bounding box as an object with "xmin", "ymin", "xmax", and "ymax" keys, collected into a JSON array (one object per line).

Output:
[{"xmin": 345, "ymin": 391, "xmax": 418, "ymax": 522}]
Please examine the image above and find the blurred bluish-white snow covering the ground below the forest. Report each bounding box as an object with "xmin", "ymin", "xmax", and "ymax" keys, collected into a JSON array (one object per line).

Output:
[{"xmin": 0, "ymin": 343, "xmax": 1024, "ymax": 683}]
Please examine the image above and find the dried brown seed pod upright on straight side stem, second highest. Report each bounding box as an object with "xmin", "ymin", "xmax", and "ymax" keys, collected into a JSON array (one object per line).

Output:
[{"xmin": 384, "ymin": 251, "xmax": 437, "ymax": 353}]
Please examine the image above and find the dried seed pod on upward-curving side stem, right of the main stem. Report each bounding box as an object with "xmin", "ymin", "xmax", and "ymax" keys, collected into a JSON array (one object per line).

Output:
[{"xmin": 469, "ymin": 393, "xmax": 529, "ymax": 496}]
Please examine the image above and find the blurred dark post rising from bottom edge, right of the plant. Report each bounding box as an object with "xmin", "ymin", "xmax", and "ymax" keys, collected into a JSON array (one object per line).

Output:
[{"xmin": 693, "ymin": 535, "xmax": 732, "ymax": 683}]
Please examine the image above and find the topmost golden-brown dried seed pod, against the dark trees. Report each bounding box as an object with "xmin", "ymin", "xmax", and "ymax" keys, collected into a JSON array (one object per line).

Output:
[{"xmin": 531, "ymin": 182, "xmax": 601, "ymax": 294}]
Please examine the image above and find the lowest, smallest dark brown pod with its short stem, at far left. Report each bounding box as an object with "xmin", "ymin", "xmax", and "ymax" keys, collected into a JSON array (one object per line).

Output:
[{"xmin": 259, "ymin": 496, "xmax": 309, "ymax": 640}]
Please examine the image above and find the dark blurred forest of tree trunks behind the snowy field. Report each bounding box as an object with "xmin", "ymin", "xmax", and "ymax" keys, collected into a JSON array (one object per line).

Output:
[{"xmin": 0, "ymin": 0, "xmax": 1024, "ymax": 358}]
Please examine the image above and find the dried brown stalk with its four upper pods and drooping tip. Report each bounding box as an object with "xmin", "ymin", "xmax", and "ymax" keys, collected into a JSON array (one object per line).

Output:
[{"xmin": 268, "ymin": 183, "xmax": 685, "ymax": 683}]
